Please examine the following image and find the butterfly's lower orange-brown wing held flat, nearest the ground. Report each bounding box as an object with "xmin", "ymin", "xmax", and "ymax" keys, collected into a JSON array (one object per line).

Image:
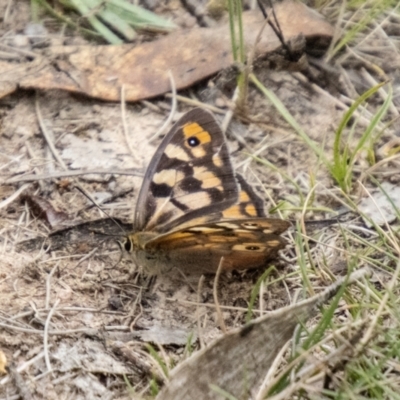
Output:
[{"xmin": 145, "ymin": 218, "xmax": 289, "ymax": 274}]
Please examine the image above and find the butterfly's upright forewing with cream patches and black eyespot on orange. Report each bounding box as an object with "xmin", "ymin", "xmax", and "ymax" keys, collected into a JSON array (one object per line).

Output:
[{"xmin": 134, "ymin": 108, "xmax": 238, "ymax": 233}]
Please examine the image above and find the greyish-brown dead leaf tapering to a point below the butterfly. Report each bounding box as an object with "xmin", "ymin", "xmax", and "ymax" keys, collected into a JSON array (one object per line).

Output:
[{"xmin": 156, "ymin": 269, "xmax": 368, "ymax": 400}]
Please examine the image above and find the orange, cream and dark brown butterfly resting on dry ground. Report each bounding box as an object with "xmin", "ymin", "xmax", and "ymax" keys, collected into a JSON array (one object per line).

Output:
[{"xmin": 124, "ymin": 108, "xmax": 289, "ymax": 274}]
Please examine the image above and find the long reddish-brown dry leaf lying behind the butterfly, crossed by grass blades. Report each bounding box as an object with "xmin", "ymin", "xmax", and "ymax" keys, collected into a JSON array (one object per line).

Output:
[{"xmin": 0, "ymin": 1, "xmax": 333, "ymax": 101}]
